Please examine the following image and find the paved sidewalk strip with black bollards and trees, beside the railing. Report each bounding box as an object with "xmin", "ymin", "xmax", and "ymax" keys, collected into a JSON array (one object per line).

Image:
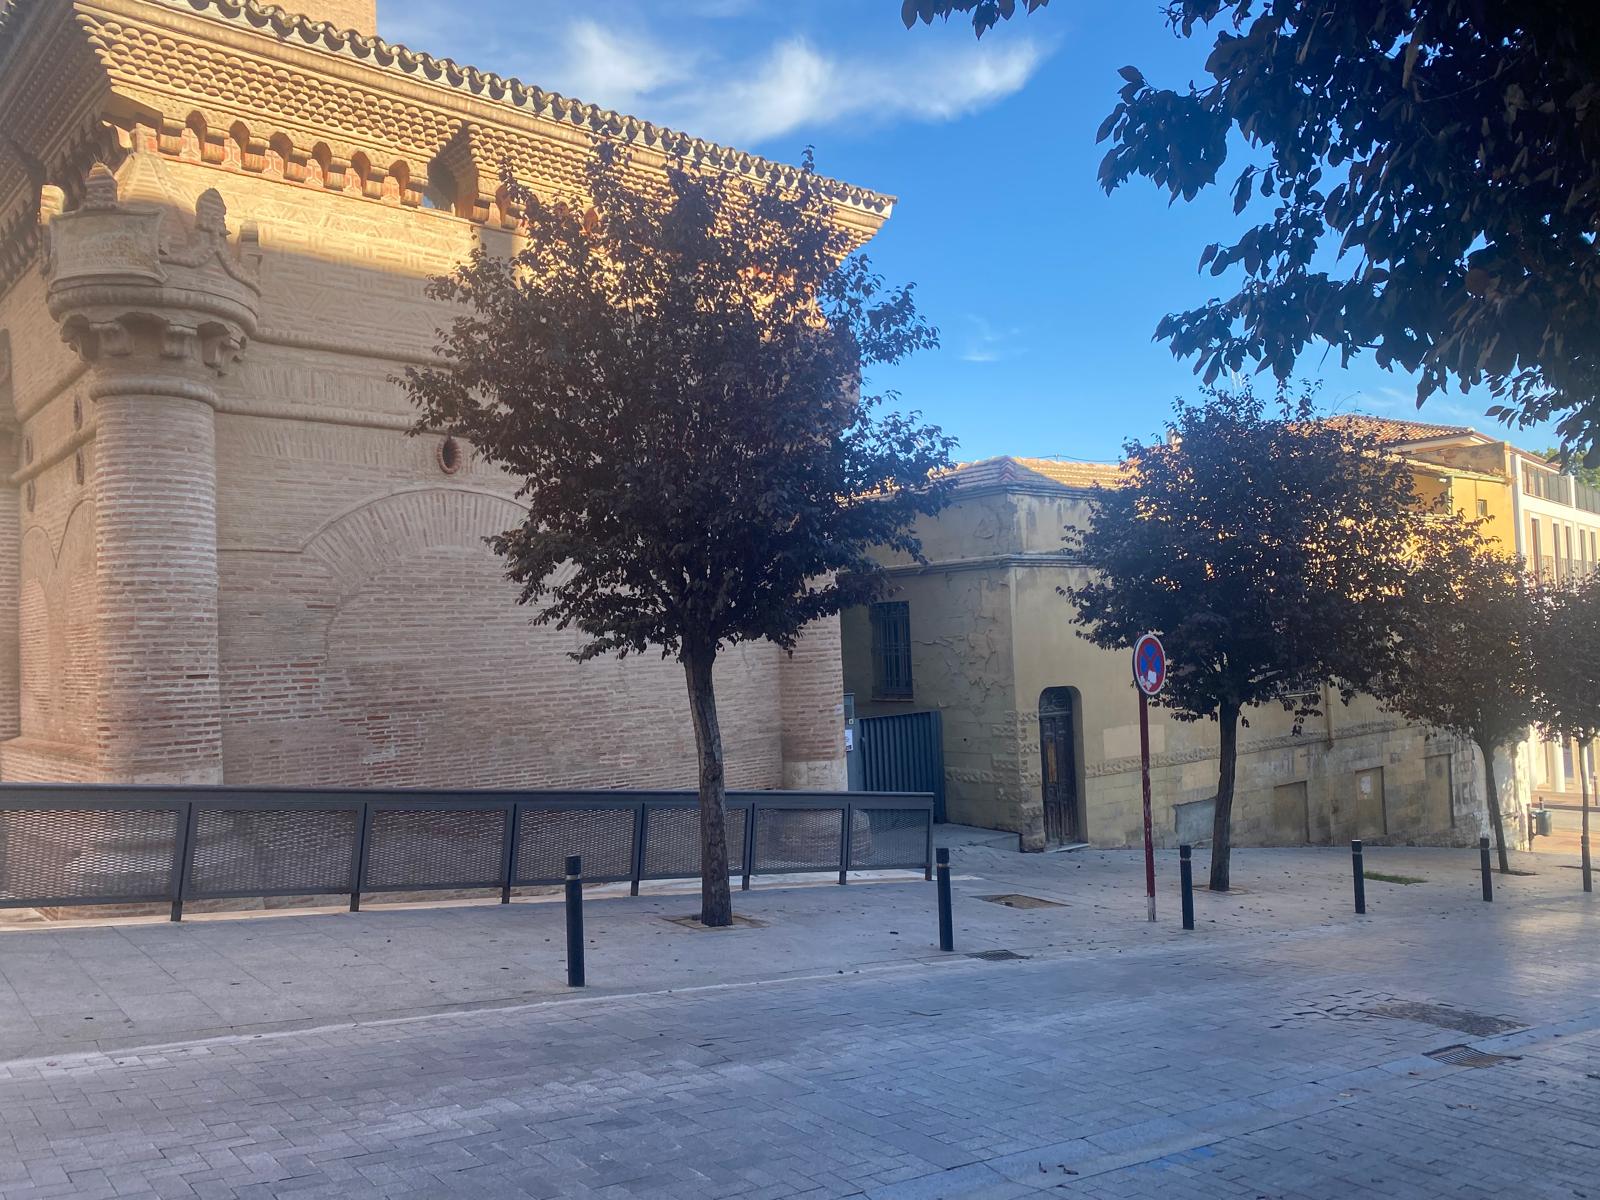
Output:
[{"xmin": 0, "ymin": 827, "xmax": 1579, "ymax": 1059}]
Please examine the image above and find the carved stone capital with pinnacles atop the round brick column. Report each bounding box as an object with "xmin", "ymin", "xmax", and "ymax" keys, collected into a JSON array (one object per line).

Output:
[{"xmin": 42, "ymin": 166, "xmax": 261, "ymax": 382}]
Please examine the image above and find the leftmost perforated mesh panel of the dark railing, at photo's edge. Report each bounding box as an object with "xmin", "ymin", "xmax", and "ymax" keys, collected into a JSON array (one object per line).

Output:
[{"xmin": 0, "ymin": 808, "xmax": 182, "ymax": 901}]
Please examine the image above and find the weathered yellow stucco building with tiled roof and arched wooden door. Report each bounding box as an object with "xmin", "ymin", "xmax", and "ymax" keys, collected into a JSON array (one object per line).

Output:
[{"xmin": 843, "ymin": 416, "xmax": 1542, "ymax": 850}]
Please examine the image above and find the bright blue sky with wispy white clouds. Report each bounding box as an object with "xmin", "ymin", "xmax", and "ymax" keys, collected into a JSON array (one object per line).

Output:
[{"xmin": 379, "ymin": 0, "xmax": 1552, "ymax": 459}]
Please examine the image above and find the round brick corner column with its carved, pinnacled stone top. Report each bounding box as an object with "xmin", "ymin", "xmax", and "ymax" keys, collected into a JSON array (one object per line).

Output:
[{"xmin": 46, "ymin": 155, "xmax": 259, "ymax": 784}]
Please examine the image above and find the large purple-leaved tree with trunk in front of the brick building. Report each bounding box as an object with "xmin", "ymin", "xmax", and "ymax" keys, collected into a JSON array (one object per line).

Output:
[{"xmin": 403, "ymin": 146, "xmax": 954, "ymax": 925}]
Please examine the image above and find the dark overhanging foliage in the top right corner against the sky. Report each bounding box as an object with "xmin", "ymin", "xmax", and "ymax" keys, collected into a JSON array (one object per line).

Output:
[{"xmin": 907, "ymin": 0, "xmax": 1600, "ymax": 466}]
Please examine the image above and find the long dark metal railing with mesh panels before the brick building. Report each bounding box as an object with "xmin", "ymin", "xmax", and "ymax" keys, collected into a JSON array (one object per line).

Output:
[{"xmin": 0, "ymin": 784, "xmax": 933, "ymax": 920}]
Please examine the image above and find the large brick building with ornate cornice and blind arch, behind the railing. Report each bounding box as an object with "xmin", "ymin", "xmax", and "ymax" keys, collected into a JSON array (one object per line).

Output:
[{"xmin": 0, "ymin": 0, "xmax": 891, "ymax": 787}]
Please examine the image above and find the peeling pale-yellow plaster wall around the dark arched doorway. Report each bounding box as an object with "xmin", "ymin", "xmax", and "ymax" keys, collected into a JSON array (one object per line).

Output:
[{"xmin": 845, "ymin": 491, "xmax": 1531, "ymax": 848}]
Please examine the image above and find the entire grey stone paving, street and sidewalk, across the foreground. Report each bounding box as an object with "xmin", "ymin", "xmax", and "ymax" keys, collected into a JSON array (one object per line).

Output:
[{"xmin": 0, "ymin": 830, "xmax": 1600, "ymax": 1200}]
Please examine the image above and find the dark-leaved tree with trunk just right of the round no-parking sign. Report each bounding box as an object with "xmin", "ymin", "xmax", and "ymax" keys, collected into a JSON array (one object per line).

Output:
[{"xmin": 1067, "ymin": 389, "xmax": 1424, "ymax": 891}]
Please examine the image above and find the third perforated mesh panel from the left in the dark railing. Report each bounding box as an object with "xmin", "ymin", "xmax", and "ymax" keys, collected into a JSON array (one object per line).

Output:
[{"xmin": 363, "ymin": 806, "xmax": 510, "ymax": 891}]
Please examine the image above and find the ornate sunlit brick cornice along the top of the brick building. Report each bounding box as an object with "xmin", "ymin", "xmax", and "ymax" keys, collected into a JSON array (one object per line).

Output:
[{"xmin": 0, "ymin": 0, "xmax": 893, "ymax": 291}]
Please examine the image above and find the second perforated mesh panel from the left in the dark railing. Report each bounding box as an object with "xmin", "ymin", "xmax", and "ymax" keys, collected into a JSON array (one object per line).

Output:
[{"xmin": 189, "ymin": 808, "xmax": 360, "ymax": 898}]
